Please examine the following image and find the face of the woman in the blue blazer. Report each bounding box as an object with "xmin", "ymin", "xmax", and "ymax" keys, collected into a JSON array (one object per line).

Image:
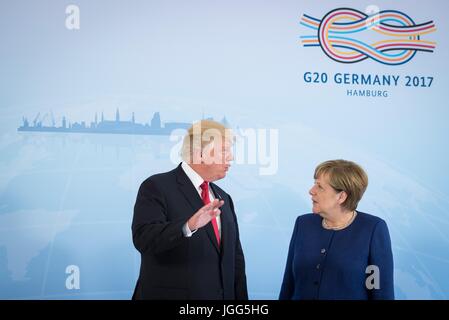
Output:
[{"xmin": 309, "ymin": 174, "xmax": 341, "ymax": 214}]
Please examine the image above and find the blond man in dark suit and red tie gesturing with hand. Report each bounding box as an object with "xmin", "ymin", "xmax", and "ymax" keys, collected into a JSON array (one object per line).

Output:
[{"xmin": 132, "ymin": 120, "xmax": 248, "ymax": 300}]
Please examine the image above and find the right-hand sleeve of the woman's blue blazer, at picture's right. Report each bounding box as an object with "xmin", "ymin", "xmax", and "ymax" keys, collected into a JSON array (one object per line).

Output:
[{"xmin": 369, "ymin": 220, "xmax": 394, "ymax": 300}]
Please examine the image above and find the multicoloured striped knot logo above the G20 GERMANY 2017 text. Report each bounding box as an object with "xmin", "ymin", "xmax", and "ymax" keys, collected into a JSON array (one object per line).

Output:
[{"xmin": 300, "ymin": 8, "xmax": 436, "ymax": 65}]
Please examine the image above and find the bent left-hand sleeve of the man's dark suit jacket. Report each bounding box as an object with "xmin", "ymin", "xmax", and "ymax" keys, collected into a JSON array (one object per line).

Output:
[{"xmin": 132, "ymin": 178, "xmax": 186, "ymax": 254}]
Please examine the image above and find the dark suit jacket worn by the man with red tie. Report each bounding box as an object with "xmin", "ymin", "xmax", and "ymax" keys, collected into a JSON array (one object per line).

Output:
[{"xmin": 132, "ymin": 165, "xmax": 248, "ymax": 300}]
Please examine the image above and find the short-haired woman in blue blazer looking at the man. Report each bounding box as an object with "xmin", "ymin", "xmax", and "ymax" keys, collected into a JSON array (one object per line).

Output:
[{"xmin": 279, "ymin": 160, "xmax": 394, "ymax": 300}]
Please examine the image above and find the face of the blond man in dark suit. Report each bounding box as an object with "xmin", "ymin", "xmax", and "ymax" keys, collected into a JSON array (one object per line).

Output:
[{"xmin": 202, "ymin": 139, "xmax": 234, "ymax": 181}]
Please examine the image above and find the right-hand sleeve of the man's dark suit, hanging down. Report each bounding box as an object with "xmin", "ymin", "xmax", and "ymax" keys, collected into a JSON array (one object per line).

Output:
[{"xmin": 228, "ymin": 195, "xmax": 248, "ymax": 300}]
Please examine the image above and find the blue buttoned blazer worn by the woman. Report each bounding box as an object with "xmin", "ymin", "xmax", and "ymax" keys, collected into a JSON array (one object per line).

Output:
[{"xmin": 279, "ymin": 211, "xmax": 394, "ymax": 300}]
